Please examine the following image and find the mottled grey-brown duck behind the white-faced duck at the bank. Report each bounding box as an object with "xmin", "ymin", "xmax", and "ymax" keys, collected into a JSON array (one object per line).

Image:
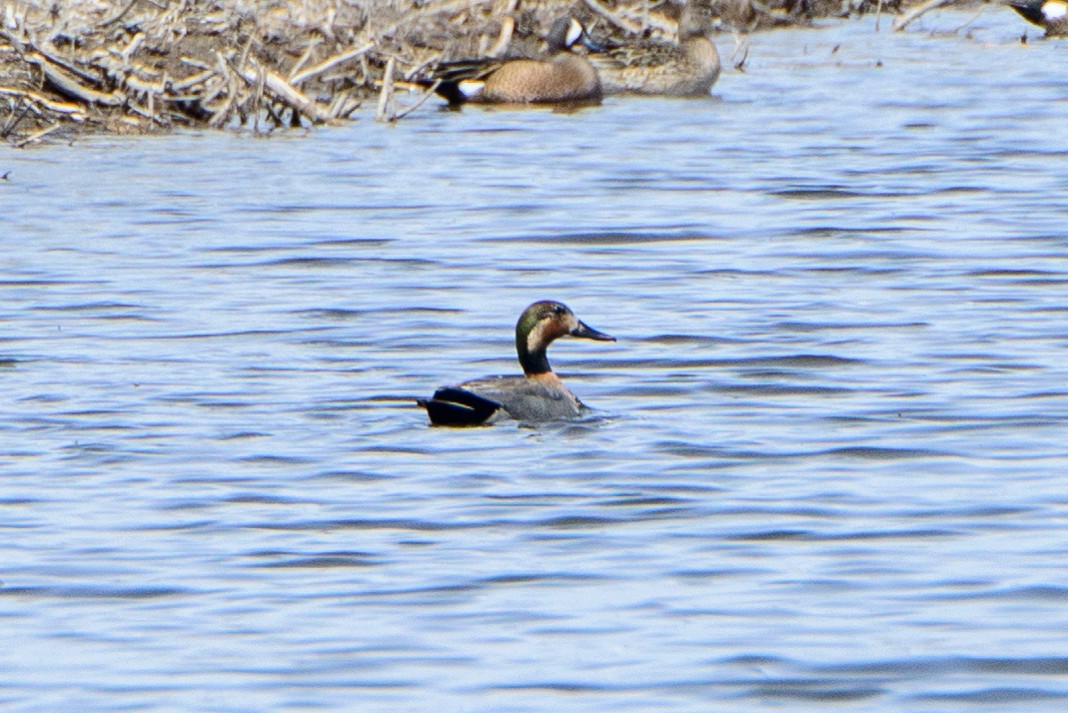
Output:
[{"xmin": 590, "ymin": 0, "xmax": 720, "ymax": 96}]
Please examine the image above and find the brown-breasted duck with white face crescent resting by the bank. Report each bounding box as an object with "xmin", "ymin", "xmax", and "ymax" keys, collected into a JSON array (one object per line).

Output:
[{"xmin": 417, "ymin": 17, "xmax": 601, "ymax": 106}]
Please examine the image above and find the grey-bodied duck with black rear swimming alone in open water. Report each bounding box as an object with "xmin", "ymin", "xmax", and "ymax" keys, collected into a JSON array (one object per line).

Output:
[{"xmin": 418, "ymin": 300, "xmax": 615, "ymax": 426}]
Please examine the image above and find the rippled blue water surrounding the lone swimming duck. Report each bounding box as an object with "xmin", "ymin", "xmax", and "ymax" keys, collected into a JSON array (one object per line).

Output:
[{"xmin": 0, "ymin": 9, "xmax": 1068, "ymax": 712}]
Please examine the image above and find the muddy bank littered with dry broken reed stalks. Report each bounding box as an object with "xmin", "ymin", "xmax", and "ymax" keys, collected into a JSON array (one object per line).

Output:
[{"xmin": 0, "ymin": 0, "xmax": 898, "ymax": 145}]
